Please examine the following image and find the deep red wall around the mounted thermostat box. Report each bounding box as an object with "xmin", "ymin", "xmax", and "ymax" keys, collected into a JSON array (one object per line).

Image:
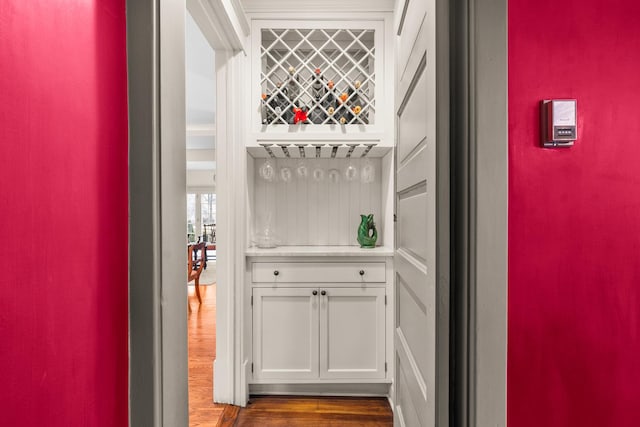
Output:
[{"xmin": 507, "ymin": 0, "xmax": 640, "ymax": 427}]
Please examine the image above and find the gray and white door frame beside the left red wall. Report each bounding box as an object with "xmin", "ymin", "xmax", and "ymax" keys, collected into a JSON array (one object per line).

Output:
[{"xmin": 127, "ymin": 0, "xmax": 189, "ymax": 427}]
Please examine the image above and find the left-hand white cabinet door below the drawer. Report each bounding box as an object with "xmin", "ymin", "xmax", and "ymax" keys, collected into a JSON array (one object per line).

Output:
[{"xmin": 253, "ymin": 288, "xmax": 319, "ymax": 380}]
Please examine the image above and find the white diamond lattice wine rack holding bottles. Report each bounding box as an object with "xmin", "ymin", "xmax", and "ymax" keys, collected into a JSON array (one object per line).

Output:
[{"xmin": 260, "ymin": 28, "xmax": 376, "ymax": 125}]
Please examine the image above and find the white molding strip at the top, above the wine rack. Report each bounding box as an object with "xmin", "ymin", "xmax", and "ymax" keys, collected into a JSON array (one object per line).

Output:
[{"xmin": 240, "ymin": 0, "xmax": 395, "ymax": 14}]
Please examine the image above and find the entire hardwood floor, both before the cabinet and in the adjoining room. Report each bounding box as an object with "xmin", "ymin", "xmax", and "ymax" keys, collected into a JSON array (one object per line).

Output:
[{"xmin": 188, "ymin": 285, "xmax": 393, "ymax": 427}]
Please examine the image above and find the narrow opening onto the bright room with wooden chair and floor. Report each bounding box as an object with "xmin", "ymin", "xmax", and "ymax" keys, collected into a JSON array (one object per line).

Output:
[{"xmin": 185, "ymin": 11, "xmax": 223, "ymax": 425}]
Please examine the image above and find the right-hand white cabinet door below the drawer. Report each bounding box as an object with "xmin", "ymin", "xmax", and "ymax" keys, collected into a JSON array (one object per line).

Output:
[{"xmin": 320, "ymin": 287, "xmax": 385, "ymax": 379}]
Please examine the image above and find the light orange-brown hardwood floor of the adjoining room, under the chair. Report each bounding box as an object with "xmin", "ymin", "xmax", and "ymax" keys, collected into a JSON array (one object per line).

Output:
[{"xmin": 188, "ymin": 285, "xmax": 228, "ymax": 427}]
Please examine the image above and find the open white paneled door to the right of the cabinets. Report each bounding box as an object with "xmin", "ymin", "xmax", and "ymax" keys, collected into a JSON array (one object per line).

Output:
[{"xmin": 394, "ymin": 0, "xmax": 436, "ymax": 427}]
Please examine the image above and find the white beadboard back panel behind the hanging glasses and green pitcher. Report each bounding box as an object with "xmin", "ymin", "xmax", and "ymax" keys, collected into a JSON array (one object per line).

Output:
[{"xmin": 252, "ymin": 158, "xmax": 384, "ymax": 246}]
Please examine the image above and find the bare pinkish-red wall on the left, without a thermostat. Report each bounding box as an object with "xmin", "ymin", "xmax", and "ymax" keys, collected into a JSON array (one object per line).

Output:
[{"xmin": 0, "ymin": 0, "xmax": 128, "ymax": 427}]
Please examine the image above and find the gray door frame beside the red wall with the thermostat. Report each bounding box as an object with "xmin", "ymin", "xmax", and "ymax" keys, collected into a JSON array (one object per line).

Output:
[{"xmin": 450, "ymin": 0, "xmax": 509, "ymax": 427}]
